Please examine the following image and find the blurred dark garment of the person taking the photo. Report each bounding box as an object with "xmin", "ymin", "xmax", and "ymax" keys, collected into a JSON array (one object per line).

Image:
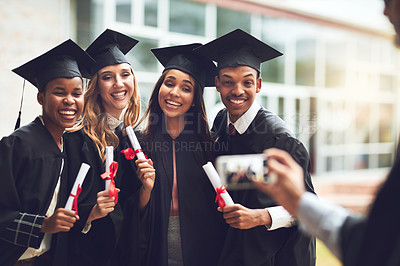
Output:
[{"xmin": 340, "ymin": 142, "xmax": 400, "ymax": 266}]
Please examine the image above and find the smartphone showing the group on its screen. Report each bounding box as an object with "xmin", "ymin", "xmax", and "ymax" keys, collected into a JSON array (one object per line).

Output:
[{"xmin": 215, "ymin": 153, "xmax": 268, "ymax": 190}]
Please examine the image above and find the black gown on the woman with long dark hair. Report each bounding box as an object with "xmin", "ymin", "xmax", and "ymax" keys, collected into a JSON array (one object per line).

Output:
[{"xmin": 119, "ymin": 123, "xmax": 227, "ymax": 266}]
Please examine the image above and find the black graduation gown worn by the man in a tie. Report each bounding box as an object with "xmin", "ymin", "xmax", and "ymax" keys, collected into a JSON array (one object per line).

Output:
[{"xmin": 212, "ymin": 108, "xmax": 316, "ymax": 266}]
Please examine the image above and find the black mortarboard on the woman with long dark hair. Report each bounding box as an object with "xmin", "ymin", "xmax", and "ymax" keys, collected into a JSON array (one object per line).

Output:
[{"xmin": 151, "ymin": 43, "xmax": 217, "ymax": 88}]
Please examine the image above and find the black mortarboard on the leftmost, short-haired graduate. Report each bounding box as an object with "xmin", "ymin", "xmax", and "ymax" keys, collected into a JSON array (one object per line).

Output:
[{"xmin": 12, "ymin": 40, "xmax": 94, "ymax": 92}]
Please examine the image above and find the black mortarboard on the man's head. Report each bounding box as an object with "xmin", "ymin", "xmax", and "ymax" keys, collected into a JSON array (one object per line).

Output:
[{"xmin": 195, "ymin": 29, "xmax": 282, "ymax": 72}]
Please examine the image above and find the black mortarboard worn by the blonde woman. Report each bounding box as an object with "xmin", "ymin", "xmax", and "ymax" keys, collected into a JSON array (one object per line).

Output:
[{"xmin": 82, "ymin": 29, "xmax": 139, "ymax": 78}]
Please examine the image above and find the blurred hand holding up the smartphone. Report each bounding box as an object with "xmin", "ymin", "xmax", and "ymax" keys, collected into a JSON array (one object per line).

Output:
[{"xmin": 254, "ymin": 148, "xmax": 305, "ymax": 216}]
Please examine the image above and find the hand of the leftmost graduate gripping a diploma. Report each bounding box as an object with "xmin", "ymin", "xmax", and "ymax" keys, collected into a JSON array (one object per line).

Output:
[{"xmin": 40, "ymin": 208, "xmax": 79, "ymax": 234}]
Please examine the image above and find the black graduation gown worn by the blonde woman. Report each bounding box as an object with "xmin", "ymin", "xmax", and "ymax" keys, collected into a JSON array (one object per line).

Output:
[{"xmin": 65, "ymin": 126, "xmax": 137, "ymax": 266}]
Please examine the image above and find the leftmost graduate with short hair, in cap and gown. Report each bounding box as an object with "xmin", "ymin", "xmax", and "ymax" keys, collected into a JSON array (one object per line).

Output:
[{"xmin": 0, "ymin": 40, "xmax": 94, "ymax": 266}]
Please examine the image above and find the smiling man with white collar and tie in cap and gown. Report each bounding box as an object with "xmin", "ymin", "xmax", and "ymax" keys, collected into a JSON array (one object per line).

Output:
[{"xmin": 196, "ymin": 29, "xmax": 315, "ymax": 266}]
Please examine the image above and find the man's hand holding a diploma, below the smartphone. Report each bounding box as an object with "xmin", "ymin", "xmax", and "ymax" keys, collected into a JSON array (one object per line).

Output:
[{"xmin": 218, "ymin": 204, "xmax": 271, "ymax": 229}]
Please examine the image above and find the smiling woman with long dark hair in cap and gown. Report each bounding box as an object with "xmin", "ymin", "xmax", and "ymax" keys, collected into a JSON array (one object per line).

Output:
[{"xmin": 121, "ymin": 44, "xmax": 227, "ymax": 266}]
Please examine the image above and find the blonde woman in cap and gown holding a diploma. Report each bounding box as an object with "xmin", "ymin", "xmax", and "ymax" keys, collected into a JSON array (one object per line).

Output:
[{"xmin": 65, "ymin": 30, "xmax": 146, "ymax": 265}]
